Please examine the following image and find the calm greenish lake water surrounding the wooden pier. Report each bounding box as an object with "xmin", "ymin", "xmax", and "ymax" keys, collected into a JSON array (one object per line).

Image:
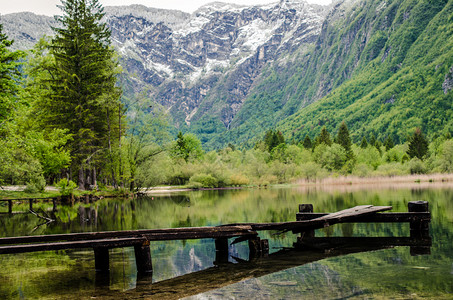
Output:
[{"xmin": 0, "ymin": 183, "xmax": 453, "ymax": 299}]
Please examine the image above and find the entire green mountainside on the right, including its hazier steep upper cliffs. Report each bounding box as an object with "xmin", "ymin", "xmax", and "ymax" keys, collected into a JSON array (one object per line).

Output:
[{"xmin": 208, "ymin": 0, "xmax": 453, "ymax": 147}]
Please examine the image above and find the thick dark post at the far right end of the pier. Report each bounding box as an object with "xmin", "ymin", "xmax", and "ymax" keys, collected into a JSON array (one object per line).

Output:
[{"xmin": 407, "ymin": 201, "xmax": 431, "ymax": 256}]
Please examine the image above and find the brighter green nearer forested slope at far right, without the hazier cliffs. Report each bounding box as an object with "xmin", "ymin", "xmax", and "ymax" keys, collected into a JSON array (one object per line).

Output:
[{"xmin": 280, "ymin": 1, "xmax": 453, "ymax": 142}]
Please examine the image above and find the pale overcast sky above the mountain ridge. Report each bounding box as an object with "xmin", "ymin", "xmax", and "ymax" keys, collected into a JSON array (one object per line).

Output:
[{"xmin": 0, "ymin": 0, "xmax": 331, "ymax": 16}]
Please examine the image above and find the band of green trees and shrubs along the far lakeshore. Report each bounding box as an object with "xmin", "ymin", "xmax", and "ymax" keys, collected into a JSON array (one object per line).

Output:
[{"xmin": 0, "ymin": 0, "xmax": 453, "ymax": 192}]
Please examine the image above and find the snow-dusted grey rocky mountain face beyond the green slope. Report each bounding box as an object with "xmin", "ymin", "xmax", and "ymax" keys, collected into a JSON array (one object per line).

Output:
[{"xmin": 1, "ymin": 0, "xmax": 327, "ymax": 128}]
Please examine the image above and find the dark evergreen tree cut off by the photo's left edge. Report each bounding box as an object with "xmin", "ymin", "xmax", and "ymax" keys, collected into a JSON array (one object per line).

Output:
[{"xmin": 0, "ymin": 24, "xmax": 25, "ymax": 126}]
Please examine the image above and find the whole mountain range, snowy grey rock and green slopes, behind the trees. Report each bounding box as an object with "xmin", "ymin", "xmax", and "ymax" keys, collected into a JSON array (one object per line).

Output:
[{"xmin": 0, "ymin": 0, "xmax": 453, "ymax": 149}]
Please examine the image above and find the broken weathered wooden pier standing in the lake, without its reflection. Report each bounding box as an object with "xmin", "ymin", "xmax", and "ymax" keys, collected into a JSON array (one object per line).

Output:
[{"xmin": 0, "ymin": 201, "xmax": 431, "ymax": 273}]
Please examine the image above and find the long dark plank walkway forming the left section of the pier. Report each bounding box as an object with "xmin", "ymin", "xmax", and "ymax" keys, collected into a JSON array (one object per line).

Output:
[{"xmin": 0, "ymin": 226, "xmax": 257, "ymax": 245}]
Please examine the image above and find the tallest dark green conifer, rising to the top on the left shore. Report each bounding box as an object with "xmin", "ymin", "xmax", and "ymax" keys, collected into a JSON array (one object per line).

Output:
[{"xmin": 40, "ymin": 0, "xmax": 122, "ymax": 188}]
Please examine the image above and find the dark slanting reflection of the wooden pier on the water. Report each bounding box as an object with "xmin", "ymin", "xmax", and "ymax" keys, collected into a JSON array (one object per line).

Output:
[{"xmin": 96, "ymin": 237, "xmax": 431, "ymax": 299}]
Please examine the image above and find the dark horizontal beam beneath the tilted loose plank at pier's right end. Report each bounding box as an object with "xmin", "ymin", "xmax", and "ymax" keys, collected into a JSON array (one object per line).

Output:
[{"xmin": 296, "ymin": 212, "xmax": 431, "ymax": 223}]
